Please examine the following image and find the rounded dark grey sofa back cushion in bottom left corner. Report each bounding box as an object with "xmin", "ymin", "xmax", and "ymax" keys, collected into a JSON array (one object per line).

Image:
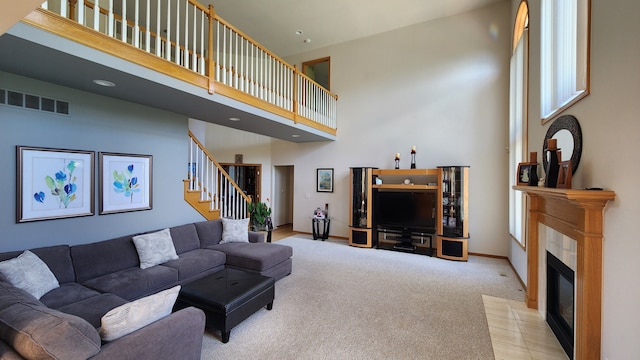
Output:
[{"xmin": 0, "ymin": 303, "xmax": 100, "ymax": 360}]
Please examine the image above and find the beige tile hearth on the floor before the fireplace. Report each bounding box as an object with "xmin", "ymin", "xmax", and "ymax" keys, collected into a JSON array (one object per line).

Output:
[{"xmin": 482, "ymin": 295, "xmax": 569, "ymax": 360}]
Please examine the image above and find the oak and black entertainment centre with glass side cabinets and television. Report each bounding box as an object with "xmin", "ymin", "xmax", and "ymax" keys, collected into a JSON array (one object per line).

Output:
[{"xmin": 349, "ymin": 166, "xmax": 469, "ymax": 261}]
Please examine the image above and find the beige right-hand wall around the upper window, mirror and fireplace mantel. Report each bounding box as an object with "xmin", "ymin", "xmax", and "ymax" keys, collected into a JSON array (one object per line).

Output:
[{"xmin": 510, "ymin": 0, "xmax": 640, "ymax": 360}]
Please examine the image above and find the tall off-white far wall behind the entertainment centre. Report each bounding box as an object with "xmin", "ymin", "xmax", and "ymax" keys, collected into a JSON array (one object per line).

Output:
[{"xmin": 272, "ymin": 2, "xmax": 510, "ymax": 256}]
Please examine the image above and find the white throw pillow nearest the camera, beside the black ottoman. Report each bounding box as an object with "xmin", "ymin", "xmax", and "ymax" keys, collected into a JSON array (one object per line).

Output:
[{"xmin": 99, "ymin": 285, "xmax": 180, "ymax": 341}]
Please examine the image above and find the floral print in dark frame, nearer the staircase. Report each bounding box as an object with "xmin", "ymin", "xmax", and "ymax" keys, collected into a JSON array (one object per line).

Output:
[{"xmin": 99, "ymin": 152, "xmax": 153, "ymax": 215}]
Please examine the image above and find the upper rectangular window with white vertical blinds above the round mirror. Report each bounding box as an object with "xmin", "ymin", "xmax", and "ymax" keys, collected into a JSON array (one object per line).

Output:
[{"xmin": 540, "ymin": 0, "xmax": 590, "ymax": 123}]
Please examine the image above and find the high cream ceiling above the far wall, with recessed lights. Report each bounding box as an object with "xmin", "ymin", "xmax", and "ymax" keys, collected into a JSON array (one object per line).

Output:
[{"xmin": 208, "ymin": 0, "xmax": 504, "ymax": 57}]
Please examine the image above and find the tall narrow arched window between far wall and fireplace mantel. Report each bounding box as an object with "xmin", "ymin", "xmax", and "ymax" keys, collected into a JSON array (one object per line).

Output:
[{"xmin": 509, "ymin": 1, "xmax": 529, "ymax": 247}]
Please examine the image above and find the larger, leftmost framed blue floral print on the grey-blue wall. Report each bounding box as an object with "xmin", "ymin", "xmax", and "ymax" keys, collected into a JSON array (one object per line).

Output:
[{"xmin": 16, "ymin": 146, "xmax": 95, "ymax": 223}]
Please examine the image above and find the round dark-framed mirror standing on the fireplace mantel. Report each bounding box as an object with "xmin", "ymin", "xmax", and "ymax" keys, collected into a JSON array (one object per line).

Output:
[{"xmin": 542, "ymin": 115, "xmax": 582, "ymax": 174}]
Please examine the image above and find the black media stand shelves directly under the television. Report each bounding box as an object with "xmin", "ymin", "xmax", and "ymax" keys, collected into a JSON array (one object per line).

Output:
[{"xmin": 376, "ymin": 228, "xmax": 435, "ymax": 256}]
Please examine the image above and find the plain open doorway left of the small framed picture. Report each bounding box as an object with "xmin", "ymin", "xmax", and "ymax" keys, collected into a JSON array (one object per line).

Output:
[{"xmin": 273, "ymin": 165, "xmax": 293, "ymax": 227}]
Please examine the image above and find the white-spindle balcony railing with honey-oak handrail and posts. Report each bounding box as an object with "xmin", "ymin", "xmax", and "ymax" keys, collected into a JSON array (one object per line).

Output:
[{"xmin": 37, "ymin": 0, "xmax": 338, "ymax": 135}]
